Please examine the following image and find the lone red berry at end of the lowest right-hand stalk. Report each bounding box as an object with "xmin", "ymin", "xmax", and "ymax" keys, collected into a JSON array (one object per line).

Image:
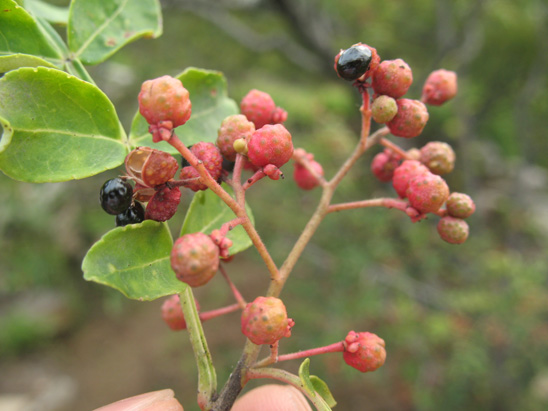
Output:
[{"xmin": 343, "ymin": 331, "xmax": 386, "ymax": 372}]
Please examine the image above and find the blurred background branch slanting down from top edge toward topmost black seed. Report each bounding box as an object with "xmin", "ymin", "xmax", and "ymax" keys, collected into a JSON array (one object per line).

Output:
[{"xmin": 162, "ymin": 0, "xmax": 334, "ymax": 72}]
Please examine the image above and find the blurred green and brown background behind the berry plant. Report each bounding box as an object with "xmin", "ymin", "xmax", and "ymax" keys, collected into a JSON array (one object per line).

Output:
[{"xmin": 0, "ymin": 0, "xmax": 548, "ymax": 410}]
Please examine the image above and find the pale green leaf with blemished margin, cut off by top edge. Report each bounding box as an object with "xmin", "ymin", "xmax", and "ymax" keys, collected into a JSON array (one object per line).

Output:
[{"xmin": 67, "ymin": 0, "xmax": 162, "ymax": 64}]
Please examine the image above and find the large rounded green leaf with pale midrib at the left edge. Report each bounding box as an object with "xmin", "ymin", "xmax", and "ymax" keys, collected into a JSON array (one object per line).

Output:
[{"xmin": 0, "ymin": 67, "xmax": 127, "ymax": 183}]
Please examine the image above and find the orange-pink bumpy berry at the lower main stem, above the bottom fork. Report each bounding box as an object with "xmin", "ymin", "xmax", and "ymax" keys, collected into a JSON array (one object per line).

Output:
[{"xmin": 241, "ymin": 297, "xmax": 294, "ymax": 345}]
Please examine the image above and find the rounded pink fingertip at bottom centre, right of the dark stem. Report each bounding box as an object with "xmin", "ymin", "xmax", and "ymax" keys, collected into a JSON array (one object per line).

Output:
[{"xmin": 232, "ymin": 384, "xmax": 312, "ymax": 411}]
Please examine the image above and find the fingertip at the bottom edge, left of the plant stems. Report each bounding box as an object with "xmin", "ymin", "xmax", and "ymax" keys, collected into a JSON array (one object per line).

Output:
[{"xmin": 91, "ymin": 390, "xmax": 184, "ymax": 411}]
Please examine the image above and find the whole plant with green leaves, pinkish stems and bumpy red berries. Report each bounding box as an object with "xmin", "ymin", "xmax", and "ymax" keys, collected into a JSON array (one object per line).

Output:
[{"xmin": 0, "ymin": 0, "xmax": 475, "ymax": 410}]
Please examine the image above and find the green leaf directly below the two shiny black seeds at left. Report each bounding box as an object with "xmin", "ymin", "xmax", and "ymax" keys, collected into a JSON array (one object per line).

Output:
[{"xmin": 82, "ymin": 220, "xmax": 184, "ymax": 301}]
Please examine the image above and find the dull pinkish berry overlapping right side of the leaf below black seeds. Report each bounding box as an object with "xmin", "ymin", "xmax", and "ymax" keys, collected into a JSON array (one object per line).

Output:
[{"xmin": 171, "ymin": 233, "xmax": 219, "ymax": 287}]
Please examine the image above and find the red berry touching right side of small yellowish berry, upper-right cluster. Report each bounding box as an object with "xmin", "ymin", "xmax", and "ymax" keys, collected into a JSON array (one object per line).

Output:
[{"xmin": 386, "ymin": 98, "xmax": 429, "ymax": 138}]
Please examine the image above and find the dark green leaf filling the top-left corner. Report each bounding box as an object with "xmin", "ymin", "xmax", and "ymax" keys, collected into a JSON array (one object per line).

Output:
[{"xmin": 0, "ymin": 0, "xmax": 65, "ymax": 67}]
